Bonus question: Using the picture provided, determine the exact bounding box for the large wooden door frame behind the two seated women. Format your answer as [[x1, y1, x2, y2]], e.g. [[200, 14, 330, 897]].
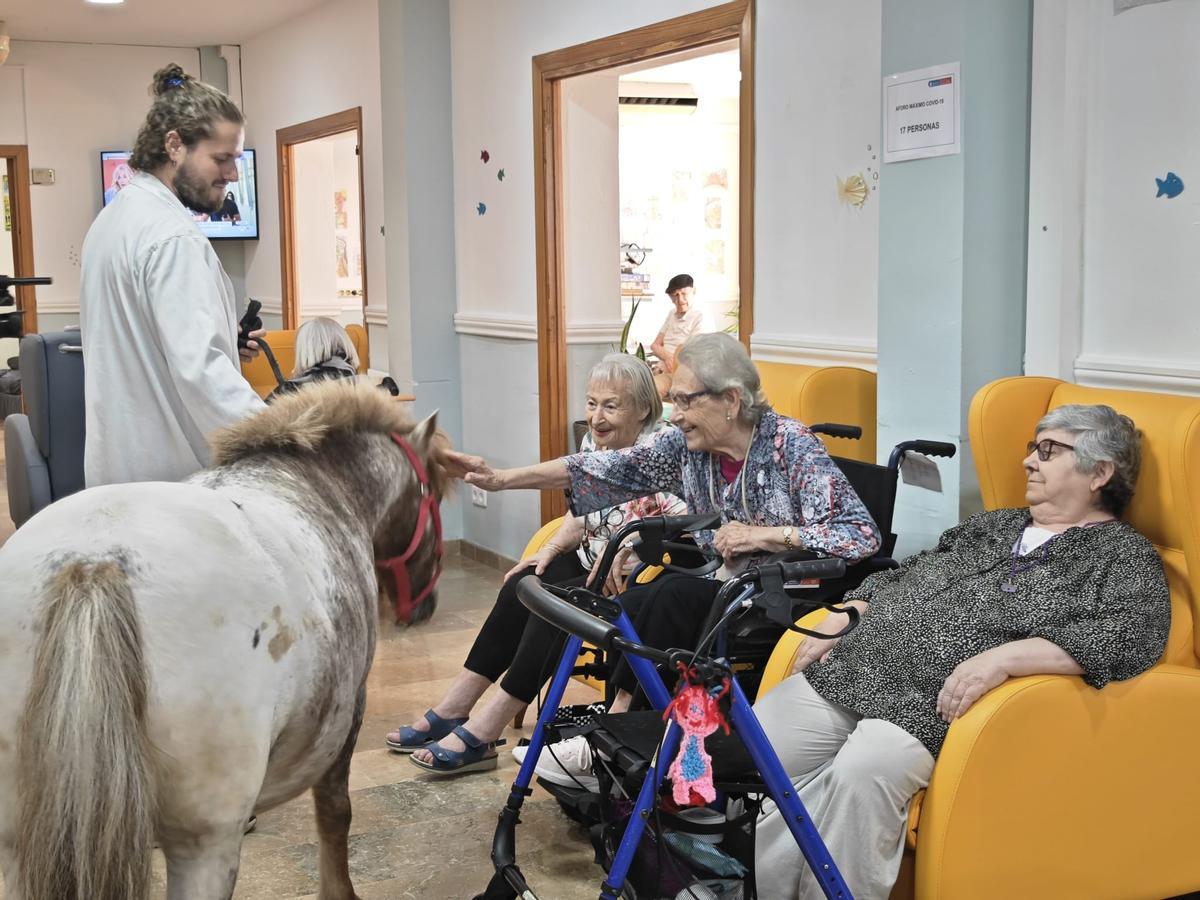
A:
[[533, 0, 755, 522]]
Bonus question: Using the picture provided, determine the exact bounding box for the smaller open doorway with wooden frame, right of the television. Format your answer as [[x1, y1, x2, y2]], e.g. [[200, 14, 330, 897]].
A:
[[276, 108, 367, 345]]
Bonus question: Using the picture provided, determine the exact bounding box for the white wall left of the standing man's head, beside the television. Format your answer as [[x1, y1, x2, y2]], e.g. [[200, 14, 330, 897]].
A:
[[0, 41, 200, 331]]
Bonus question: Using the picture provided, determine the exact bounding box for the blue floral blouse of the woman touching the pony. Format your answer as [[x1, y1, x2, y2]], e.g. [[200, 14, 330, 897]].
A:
[[565, 409, 880, 571]]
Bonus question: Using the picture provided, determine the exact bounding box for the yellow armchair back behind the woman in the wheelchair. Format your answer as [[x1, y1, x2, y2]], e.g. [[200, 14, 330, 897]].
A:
[[755, 362, 877, 462]]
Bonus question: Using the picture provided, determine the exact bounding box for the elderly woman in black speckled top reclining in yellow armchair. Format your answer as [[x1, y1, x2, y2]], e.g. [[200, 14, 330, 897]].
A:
[[755, 406, 1171, 899]]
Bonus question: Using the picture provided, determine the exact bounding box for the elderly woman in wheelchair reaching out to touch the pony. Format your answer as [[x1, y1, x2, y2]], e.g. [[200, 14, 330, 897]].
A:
[[446, 334, 880, 782]]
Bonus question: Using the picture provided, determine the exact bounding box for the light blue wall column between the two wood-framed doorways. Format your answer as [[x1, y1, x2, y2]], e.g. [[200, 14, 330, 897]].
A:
[[379, 0, 466, 540]]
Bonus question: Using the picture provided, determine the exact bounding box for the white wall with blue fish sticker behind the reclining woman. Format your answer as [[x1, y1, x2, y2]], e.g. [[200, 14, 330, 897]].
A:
[[1026, 0, 1200, 394]]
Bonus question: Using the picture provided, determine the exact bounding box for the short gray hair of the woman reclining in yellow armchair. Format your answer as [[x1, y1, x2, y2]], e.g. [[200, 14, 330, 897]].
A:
[[1034, 403, 1141, 516]]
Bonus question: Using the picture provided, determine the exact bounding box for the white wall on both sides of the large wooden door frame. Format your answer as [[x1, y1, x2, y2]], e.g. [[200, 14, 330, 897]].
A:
[[450, 0, 881, 556]]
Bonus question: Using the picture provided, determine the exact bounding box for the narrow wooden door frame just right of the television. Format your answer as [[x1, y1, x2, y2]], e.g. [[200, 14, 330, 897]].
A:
[[275, 107, 367, 331]]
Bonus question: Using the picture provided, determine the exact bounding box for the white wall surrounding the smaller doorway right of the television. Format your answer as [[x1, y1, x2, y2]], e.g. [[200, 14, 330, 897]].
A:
[[241, 0, 396, 376]]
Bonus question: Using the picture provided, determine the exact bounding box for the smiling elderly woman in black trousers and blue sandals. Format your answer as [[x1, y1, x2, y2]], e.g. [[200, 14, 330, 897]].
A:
[[386, 353, 684, 774]]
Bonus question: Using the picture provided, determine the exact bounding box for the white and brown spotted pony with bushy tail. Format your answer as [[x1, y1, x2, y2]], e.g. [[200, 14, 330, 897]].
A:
[[0, 382, 442, 900]]
